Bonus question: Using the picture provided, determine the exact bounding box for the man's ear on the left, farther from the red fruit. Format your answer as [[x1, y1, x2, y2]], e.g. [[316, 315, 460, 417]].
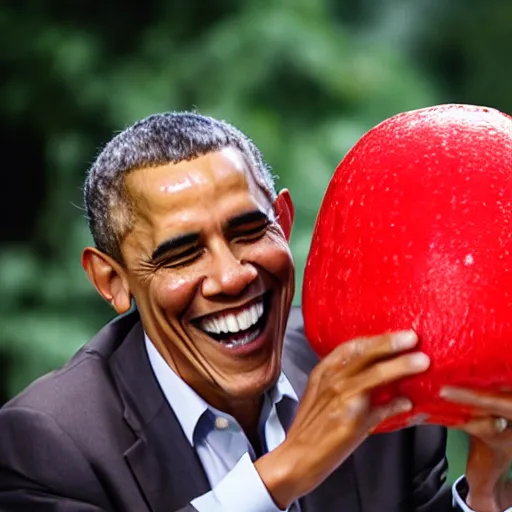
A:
[[82, 247, 131, 315]]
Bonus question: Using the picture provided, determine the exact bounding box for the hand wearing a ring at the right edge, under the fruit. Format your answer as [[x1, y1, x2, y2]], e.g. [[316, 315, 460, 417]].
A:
[[441, 388, 512, 512]]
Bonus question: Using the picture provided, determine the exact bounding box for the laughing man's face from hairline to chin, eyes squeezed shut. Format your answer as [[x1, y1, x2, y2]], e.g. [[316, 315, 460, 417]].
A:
[[121, 148, 294, 405]]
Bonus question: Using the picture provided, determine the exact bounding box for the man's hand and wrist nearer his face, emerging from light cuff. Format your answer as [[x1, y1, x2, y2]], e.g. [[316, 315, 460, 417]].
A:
[[255, 331, 430, 508]]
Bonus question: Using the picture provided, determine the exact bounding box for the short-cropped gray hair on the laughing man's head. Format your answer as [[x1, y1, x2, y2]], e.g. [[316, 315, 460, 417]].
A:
[[84, 112, 276, 263]]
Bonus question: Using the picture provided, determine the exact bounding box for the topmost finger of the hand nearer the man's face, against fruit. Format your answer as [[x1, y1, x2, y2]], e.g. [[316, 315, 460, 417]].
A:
[[324, 331, 418, 373]]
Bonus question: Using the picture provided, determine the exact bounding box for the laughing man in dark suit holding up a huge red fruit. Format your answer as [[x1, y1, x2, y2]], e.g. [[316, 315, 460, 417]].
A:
[[0, 113, 509, 512]]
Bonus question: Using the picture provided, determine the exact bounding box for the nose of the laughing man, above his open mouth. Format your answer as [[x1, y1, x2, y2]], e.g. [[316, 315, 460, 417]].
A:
[[202, 244, 258, 297]]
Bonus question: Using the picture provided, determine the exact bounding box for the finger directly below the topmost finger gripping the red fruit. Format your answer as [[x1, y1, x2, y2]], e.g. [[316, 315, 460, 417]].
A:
[[351, 352, 430, 392]]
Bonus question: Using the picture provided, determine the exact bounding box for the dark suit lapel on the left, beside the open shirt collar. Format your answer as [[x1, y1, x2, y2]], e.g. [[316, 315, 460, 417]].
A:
[[110, 322, 210, 512]]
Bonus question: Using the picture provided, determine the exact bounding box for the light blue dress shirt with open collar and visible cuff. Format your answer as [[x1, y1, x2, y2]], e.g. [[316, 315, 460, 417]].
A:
[[145, 336, 300, 512]]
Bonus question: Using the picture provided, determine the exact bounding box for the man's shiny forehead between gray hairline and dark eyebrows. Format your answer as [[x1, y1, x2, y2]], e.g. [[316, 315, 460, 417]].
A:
[[126, 147, 268, 227]]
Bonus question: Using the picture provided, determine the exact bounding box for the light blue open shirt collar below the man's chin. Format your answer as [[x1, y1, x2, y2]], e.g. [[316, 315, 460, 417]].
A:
[[144, 333, 299, 446]]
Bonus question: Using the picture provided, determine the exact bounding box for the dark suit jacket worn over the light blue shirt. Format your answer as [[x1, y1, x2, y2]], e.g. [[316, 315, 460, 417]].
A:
[[0, 309, 451, 512]]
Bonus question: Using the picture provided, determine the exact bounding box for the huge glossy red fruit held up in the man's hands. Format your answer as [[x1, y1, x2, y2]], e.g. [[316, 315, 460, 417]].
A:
[[303, 105, 512, 432]]
